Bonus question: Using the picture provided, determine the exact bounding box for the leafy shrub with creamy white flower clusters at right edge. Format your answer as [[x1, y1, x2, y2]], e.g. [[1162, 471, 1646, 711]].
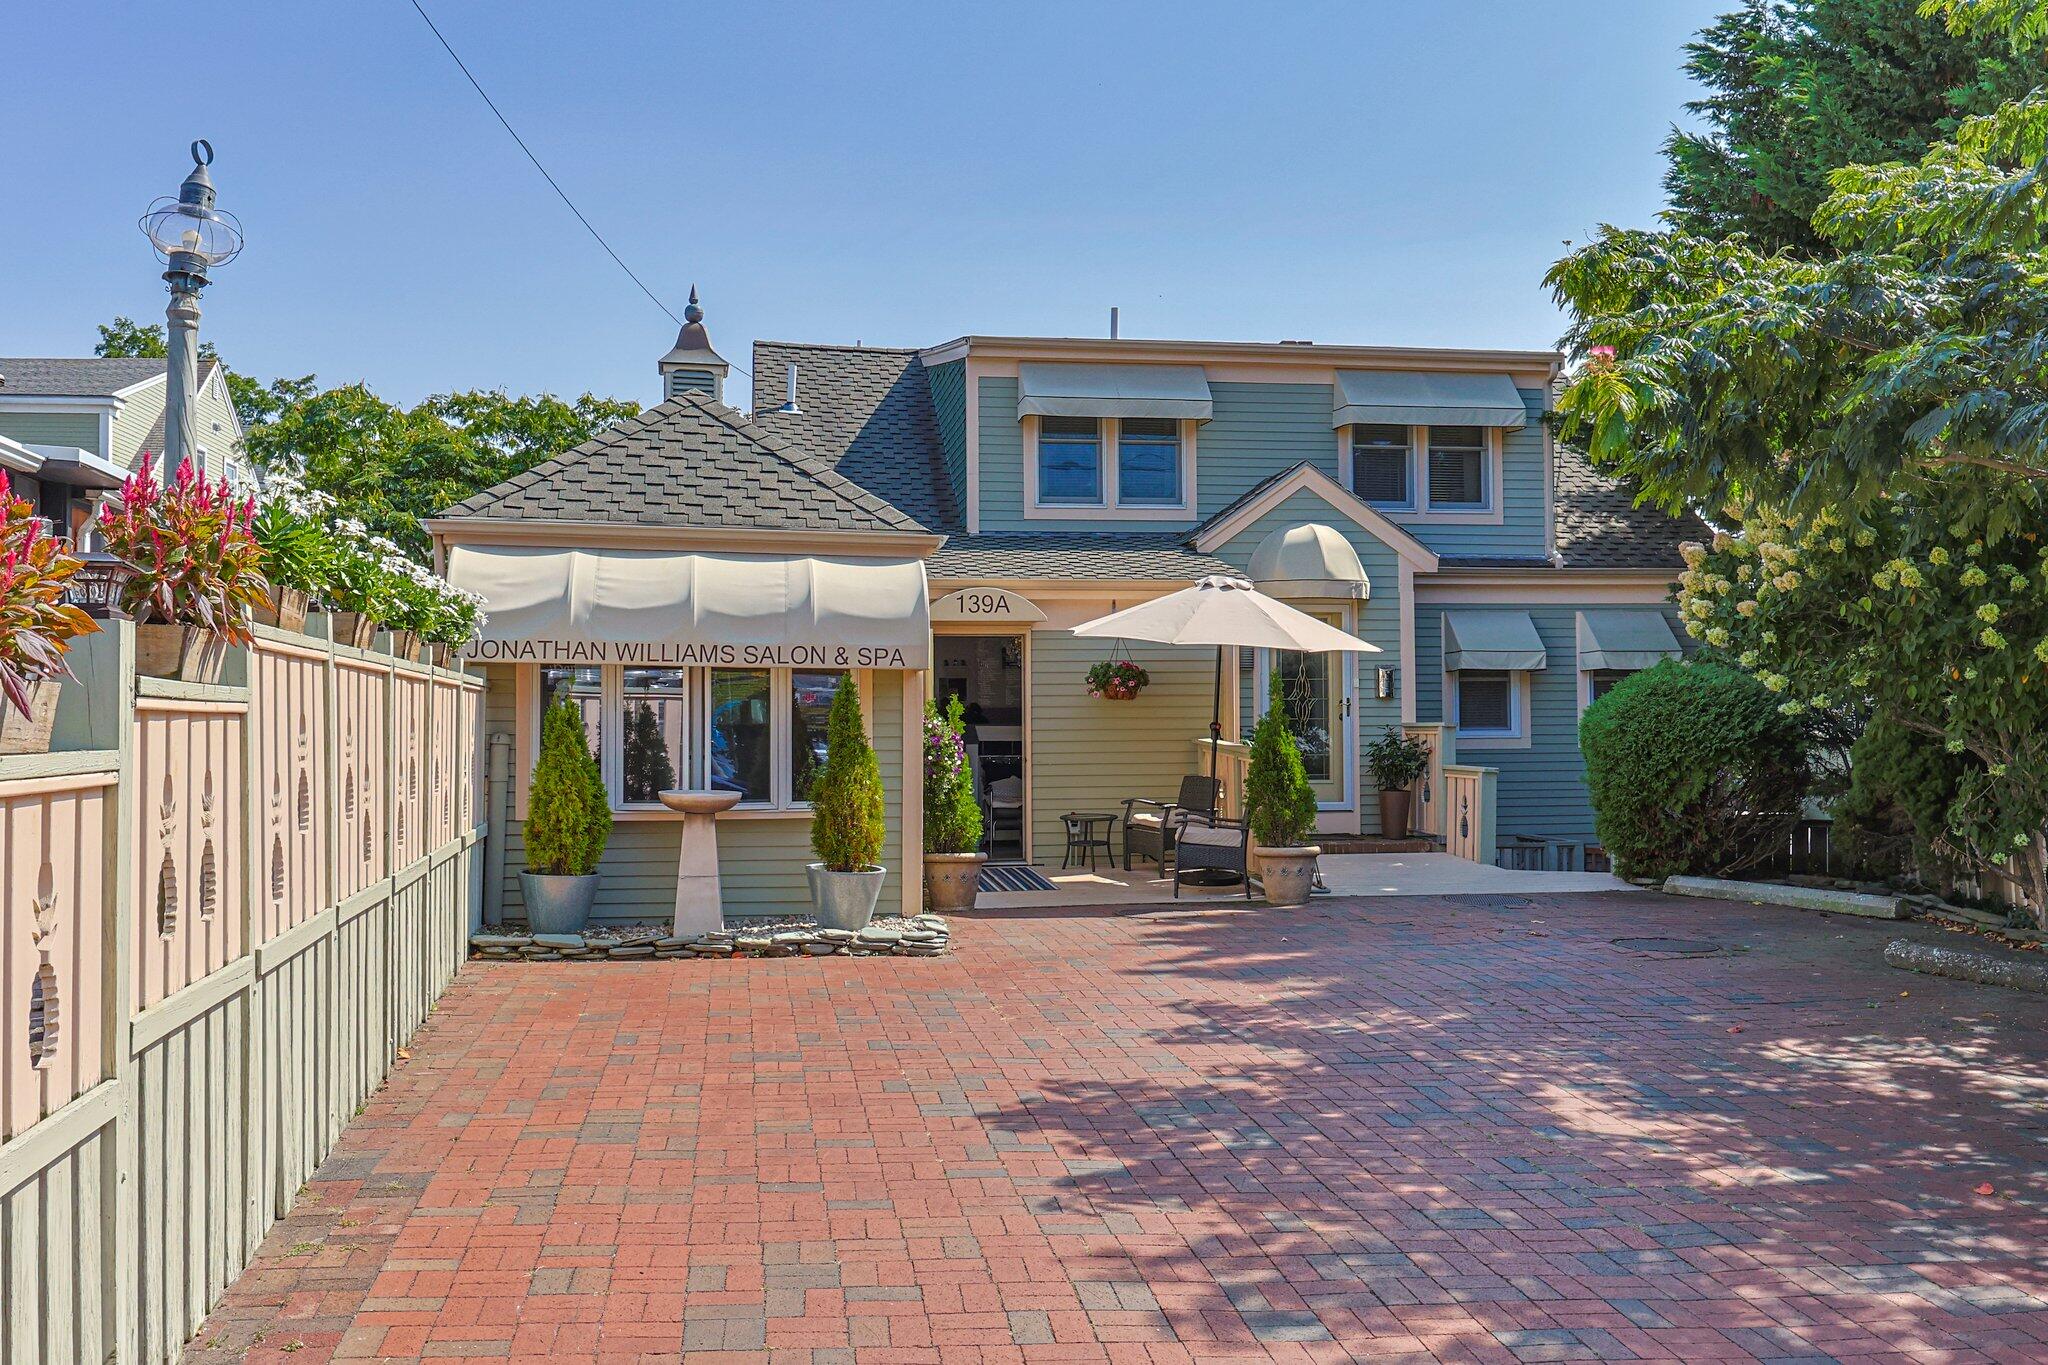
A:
[[1679, 485, 2048, 927]]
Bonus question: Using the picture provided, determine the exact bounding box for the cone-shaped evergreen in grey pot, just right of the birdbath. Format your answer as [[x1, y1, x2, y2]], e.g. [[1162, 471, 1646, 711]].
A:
[[807, 677, 887, 929]]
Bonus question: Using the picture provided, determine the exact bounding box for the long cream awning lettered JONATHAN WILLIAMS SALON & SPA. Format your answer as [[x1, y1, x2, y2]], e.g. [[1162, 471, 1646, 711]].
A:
[[449, 544, 932, 669]]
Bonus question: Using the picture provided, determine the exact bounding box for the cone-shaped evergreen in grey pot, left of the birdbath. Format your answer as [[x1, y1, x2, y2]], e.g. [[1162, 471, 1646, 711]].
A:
[[518, 696, 612, 933]]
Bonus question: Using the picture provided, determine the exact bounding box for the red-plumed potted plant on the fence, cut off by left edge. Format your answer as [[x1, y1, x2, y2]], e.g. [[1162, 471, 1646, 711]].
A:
[[0, 473, 98, 753]]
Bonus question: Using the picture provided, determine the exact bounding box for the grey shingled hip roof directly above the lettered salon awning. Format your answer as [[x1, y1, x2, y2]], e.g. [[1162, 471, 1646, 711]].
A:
[[442, 391, 937, 532]]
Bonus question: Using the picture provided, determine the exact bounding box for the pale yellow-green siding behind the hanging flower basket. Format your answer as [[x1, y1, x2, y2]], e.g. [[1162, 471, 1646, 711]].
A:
[[1030, 626, 1217, 868]]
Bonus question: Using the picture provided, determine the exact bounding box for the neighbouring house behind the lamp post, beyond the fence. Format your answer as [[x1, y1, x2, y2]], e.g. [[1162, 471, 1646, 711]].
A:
[[0, 356, 244, 532]]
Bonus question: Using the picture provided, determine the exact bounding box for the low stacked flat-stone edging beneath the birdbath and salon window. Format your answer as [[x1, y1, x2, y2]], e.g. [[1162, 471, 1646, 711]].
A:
[[469, 915, 952, 962]]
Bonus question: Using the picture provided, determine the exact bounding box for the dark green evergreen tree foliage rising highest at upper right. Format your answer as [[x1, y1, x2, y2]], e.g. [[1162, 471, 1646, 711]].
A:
[[1665, 0, 2038, 254]]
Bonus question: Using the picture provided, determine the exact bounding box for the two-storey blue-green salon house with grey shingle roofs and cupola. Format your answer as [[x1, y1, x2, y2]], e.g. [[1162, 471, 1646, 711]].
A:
[[430, 296, 1706, 915]]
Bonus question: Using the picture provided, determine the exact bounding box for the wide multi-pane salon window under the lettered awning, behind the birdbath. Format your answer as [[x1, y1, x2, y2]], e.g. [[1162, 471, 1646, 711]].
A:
[[528, 665, 848, 810]]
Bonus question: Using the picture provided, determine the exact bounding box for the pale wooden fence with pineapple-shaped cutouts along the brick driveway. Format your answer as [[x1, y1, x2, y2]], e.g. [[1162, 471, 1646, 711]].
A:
[[0, 624, 483, 1365]]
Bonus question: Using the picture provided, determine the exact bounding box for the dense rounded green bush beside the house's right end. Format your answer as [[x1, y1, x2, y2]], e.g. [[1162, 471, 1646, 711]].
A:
[[1579, 659, 1808, 876]]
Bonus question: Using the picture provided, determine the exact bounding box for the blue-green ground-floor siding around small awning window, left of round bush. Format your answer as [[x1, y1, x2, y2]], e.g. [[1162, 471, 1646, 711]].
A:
[[1415, 596, 1690, 839]]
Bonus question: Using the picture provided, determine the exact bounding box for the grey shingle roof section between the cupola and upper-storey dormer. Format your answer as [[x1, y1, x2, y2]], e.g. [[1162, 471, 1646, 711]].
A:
[[754, 342, 958, 532]]
